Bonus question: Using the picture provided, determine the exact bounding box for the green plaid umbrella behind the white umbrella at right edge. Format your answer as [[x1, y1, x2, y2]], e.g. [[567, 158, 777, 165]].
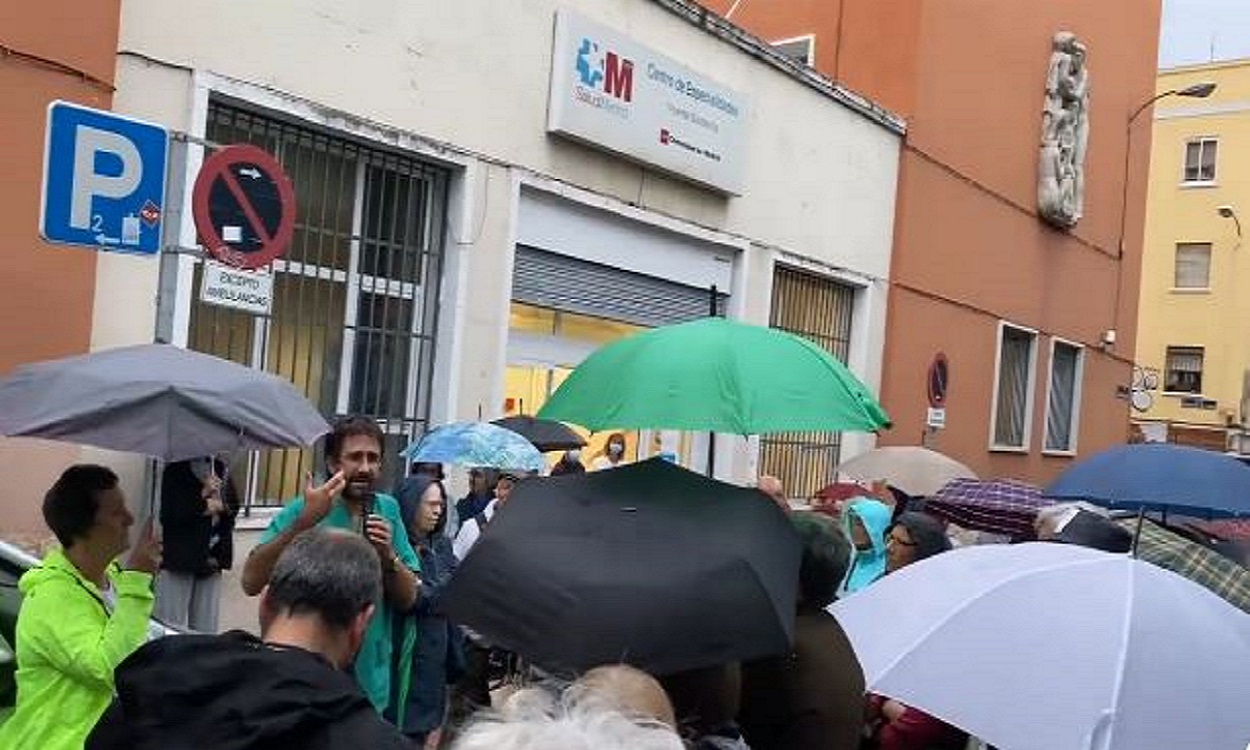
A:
[[1116, 519, 1250, 613]]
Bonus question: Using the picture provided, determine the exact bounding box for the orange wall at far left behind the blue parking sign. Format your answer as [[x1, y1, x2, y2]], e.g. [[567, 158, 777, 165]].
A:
[[0, 0, 120, 533]]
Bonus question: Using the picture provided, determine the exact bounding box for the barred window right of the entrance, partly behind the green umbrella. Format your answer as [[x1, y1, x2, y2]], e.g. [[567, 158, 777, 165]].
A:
[[760, 266, 855, 498]]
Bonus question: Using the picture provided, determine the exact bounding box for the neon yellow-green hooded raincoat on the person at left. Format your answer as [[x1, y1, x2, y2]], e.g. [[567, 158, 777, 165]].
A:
[[0, 550, 153, 750]]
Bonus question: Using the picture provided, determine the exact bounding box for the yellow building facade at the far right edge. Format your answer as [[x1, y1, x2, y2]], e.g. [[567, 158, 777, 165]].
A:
[[1134, 60, 1250, 453]]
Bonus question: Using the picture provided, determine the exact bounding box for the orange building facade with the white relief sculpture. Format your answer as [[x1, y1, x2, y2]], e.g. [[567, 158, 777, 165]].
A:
[[706, 0, 1160, 483]]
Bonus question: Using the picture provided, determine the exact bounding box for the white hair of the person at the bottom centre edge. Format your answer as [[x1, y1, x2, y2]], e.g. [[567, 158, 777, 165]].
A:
[[451, 688, 683, 750]]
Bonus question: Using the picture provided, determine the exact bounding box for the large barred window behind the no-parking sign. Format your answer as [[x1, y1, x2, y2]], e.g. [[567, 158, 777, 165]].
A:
[[189, 101, 448, 505]]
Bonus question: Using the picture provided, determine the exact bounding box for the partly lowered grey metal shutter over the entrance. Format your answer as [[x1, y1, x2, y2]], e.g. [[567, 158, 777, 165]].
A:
[[513, 245, 729, 326]]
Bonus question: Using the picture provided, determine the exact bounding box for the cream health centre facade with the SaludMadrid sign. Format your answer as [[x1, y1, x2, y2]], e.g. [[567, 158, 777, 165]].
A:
[[0, 0, 903, 530]]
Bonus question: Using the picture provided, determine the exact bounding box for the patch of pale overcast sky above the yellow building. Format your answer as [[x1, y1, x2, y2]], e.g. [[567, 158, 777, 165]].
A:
[[1159, 0, 1250, 68]]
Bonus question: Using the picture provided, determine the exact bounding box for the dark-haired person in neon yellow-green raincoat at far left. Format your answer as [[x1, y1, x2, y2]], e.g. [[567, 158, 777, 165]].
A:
[[0, 465, 160, 750]]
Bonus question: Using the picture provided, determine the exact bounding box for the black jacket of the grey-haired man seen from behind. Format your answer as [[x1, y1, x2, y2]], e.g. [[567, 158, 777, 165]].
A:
[[85, 631, 411, 750]]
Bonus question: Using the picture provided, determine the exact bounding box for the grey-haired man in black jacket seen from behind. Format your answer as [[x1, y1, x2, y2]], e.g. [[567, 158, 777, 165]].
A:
[[89, 529, 411, 750]]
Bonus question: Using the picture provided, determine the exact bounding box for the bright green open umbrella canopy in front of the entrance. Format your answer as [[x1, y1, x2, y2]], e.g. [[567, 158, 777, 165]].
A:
[[539, 318, 890, 435]]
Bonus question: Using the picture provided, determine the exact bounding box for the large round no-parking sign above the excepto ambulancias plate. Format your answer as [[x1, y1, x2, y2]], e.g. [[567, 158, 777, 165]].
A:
[[191, 145, 295, 269]]
